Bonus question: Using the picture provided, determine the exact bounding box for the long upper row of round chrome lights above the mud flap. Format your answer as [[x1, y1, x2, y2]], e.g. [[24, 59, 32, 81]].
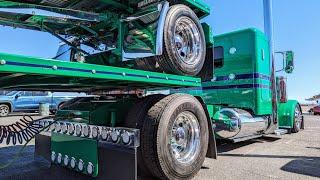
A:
[[39, 120, 139, 147]]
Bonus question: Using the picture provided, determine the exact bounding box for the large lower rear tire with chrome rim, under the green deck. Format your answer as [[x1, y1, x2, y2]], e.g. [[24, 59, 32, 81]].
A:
[[127, 94, 209, 179]]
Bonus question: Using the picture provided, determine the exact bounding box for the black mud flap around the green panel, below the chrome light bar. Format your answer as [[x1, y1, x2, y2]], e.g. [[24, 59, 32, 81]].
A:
[[35, 134, 138, 180]]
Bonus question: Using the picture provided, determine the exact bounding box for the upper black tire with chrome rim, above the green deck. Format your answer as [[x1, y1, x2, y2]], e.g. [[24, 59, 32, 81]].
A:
[[137, 4, 206, 76]]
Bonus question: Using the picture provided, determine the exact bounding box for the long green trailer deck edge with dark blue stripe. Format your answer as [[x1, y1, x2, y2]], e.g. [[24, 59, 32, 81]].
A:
[[0, 53, 201, 92]]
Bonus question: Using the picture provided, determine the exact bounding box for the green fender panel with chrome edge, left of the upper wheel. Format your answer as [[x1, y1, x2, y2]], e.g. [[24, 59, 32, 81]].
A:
[[119, 1, 170, 61]]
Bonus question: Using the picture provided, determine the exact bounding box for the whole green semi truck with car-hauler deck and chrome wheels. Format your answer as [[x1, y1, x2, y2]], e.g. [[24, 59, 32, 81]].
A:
[[0, 0, 303, 179]]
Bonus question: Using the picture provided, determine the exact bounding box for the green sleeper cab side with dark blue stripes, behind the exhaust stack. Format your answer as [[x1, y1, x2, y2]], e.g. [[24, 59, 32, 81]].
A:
[[202, 29, 272, 115]]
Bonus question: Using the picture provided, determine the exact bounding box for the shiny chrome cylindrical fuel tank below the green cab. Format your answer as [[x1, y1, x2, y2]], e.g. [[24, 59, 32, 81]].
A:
[[214, 108, 269, 140]]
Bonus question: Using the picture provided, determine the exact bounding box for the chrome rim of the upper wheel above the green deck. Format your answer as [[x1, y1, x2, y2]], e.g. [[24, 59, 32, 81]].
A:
[[174, 17, 203, 65]]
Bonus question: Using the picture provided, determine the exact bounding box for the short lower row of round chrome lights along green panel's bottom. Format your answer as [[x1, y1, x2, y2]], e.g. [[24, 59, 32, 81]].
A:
[[51, 151, 95, 175]]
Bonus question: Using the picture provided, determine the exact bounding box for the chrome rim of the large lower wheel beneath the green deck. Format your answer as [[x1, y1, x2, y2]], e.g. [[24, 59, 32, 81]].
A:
[[170, 111, 200, 164]]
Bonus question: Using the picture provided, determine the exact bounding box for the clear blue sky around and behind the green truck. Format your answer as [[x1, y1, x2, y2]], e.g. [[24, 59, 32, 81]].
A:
[[0, 0, 320, 101]]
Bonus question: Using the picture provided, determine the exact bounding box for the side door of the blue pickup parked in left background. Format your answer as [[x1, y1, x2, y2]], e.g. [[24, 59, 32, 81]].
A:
[[14, 91, 34, 111]]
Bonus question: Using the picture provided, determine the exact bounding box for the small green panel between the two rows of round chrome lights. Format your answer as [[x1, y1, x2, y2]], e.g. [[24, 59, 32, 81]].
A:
[[51, 132, 99, 177]]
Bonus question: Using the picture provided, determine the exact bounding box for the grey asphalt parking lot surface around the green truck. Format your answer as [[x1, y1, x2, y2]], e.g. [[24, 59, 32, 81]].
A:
[[0, 115, 320, 180]]
